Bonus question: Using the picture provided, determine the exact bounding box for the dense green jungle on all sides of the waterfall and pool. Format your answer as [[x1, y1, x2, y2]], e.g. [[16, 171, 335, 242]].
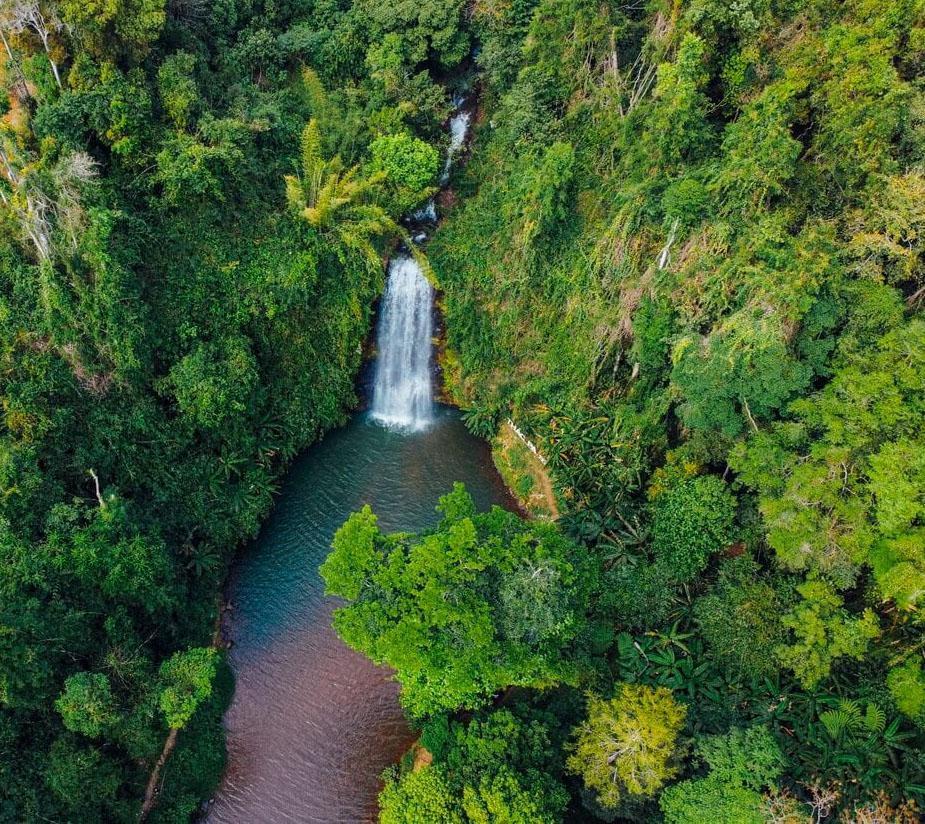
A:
[[0, 0, 925, 824]]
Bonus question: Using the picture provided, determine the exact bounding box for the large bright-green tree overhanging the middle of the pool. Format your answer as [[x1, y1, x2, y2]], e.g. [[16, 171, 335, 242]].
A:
[[321, 484, 584, 717]]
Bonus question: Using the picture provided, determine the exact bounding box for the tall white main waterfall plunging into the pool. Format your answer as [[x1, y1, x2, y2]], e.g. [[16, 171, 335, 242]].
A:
[[372, 254, 433, 431]]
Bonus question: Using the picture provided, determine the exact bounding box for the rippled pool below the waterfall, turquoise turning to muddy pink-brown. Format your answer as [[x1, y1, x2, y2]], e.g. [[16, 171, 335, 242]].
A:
[[208, 407, 511, 824]]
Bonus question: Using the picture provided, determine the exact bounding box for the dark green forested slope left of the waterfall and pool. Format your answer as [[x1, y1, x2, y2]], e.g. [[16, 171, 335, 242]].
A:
[[0, 0, 458, 822]]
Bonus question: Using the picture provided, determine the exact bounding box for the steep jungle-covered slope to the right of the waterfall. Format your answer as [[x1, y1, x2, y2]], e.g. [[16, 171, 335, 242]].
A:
[[430, 0, 925, 821]]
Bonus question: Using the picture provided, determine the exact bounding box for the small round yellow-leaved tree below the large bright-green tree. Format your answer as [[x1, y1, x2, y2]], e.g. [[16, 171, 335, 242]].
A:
[[567, 684, 687, 807]]
